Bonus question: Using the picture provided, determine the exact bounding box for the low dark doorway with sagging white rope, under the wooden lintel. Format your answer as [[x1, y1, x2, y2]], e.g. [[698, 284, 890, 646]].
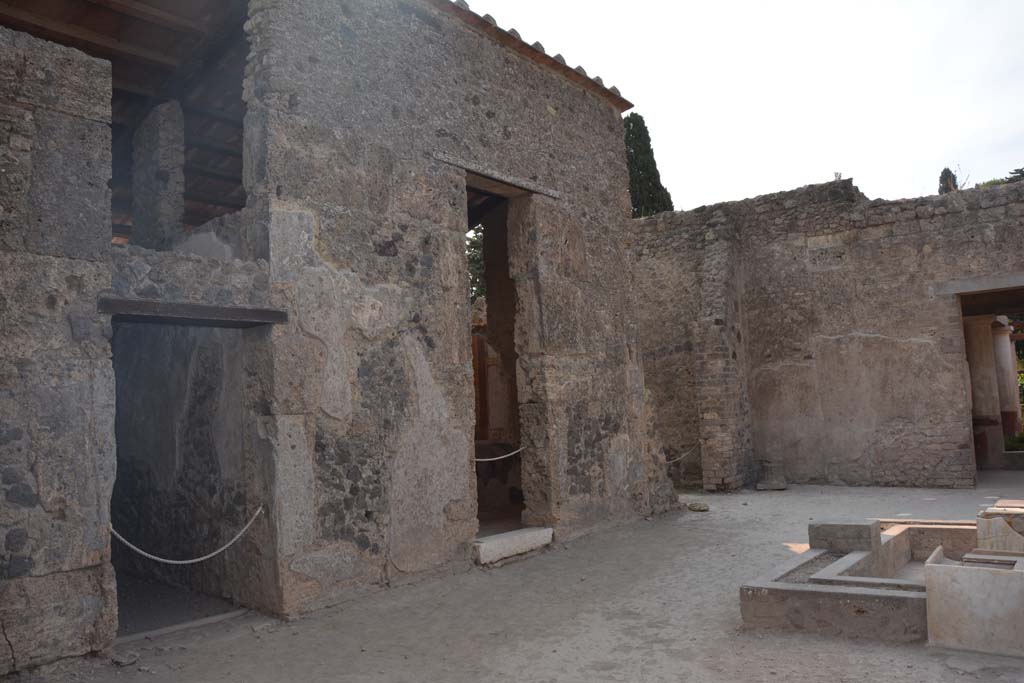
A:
[[111, 321, 255, 637]]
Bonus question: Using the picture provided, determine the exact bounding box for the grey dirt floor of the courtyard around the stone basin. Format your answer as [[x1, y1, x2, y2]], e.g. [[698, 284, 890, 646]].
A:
[[19, 472, 1024, 683]]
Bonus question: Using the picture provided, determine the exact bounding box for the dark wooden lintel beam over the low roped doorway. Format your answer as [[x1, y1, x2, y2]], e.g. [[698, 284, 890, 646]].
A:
[[96, 297, 288, 328]]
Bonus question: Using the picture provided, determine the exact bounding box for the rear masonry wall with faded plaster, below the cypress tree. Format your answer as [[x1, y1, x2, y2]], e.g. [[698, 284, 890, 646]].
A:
[[631, 180, 1024, 487]]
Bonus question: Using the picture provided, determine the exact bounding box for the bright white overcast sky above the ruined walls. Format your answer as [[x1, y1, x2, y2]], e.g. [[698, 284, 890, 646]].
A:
[[469, 0, 1024, 209]]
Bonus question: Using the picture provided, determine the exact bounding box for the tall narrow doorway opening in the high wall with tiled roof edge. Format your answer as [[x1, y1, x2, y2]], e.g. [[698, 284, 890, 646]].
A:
[[467, 183, 525, 537]]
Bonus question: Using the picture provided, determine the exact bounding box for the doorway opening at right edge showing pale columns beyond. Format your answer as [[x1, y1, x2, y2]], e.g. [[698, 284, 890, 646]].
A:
[[961, 288, 1024, 470]]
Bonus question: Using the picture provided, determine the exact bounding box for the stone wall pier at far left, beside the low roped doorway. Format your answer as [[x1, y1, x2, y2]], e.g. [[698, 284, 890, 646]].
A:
[[0, 29, 116, 675]]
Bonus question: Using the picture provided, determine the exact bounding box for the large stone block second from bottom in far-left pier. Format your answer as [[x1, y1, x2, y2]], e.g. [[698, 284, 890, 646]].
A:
[[0, 359, 115, 578]]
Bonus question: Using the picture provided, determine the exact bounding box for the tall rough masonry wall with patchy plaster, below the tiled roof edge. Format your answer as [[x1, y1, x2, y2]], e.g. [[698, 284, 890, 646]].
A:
[[246, 0, 669, 612]]
